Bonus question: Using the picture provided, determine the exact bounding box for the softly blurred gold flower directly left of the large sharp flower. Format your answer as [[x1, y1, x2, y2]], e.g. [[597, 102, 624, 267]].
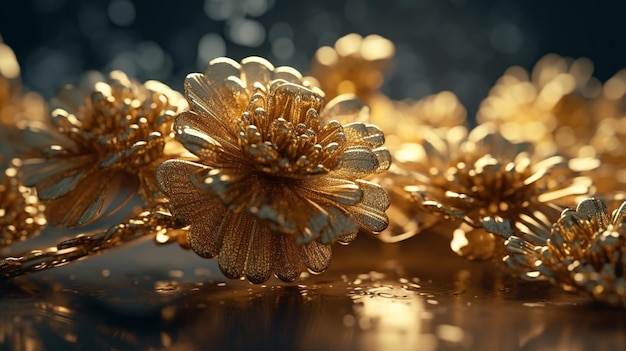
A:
[[22, 71, 186, 227]]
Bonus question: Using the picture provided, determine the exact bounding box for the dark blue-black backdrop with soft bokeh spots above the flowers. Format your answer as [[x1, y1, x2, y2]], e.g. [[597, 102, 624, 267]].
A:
[[0, 0, 626, 117]]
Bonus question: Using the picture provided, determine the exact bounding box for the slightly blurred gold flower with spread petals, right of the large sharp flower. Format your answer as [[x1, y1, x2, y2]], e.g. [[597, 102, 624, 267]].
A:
[[376, 124, 597, 259]]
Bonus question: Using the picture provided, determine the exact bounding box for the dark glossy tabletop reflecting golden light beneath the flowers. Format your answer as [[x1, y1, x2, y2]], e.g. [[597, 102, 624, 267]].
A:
[[0, 233, 626, 350]]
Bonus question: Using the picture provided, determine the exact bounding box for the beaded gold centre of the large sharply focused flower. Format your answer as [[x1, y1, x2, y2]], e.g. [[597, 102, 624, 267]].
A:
[[237, 80, 346, 178]]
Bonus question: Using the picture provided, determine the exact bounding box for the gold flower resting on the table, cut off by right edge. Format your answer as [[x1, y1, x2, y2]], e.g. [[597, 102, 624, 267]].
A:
[[506, 199, 626, 306]]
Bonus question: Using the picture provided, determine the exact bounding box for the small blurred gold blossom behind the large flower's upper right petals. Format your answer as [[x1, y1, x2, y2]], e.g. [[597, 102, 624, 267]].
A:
[[309, 33, 395, 103]]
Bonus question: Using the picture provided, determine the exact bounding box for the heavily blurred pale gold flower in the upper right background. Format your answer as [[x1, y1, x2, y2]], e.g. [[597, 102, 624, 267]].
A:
[[476, 54, 595, 152]]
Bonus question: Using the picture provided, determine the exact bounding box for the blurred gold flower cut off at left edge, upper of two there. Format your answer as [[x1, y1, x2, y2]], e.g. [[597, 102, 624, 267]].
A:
[[0, 38, 47, 163]]
